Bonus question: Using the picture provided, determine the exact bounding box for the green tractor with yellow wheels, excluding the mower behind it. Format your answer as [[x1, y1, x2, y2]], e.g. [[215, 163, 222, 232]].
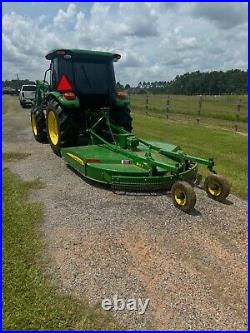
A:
[[31, 50, 132, 155]]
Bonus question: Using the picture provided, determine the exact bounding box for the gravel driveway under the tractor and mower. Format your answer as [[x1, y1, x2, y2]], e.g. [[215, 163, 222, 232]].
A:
[[3, 97, 247, 330]]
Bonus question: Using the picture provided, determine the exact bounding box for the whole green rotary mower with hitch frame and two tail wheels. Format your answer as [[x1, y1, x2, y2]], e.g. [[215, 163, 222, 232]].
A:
[[58, 110, 230, 212]]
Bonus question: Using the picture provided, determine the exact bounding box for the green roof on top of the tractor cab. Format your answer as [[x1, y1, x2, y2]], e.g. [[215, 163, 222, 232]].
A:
[[45, 49, 121, 61]]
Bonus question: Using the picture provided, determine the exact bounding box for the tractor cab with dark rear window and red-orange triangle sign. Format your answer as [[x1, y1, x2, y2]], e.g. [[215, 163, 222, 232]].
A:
[[46, 49, 121, 108]]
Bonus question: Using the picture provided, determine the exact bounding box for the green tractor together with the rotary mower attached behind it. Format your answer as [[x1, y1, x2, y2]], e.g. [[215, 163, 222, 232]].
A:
[[31, 49, 230, 212]]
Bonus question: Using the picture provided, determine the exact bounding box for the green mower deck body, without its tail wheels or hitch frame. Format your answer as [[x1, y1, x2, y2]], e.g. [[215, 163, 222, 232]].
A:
[[61, 141, 198, 191]]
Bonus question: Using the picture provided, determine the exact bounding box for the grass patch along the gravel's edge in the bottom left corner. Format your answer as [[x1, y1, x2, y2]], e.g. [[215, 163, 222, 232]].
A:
[[2, 153, 116, 330]]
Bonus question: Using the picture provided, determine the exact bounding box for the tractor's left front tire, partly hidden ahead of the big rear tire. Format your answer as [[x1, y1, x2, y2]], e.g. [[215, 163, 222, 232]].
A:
[[30, 108, 47, 143]]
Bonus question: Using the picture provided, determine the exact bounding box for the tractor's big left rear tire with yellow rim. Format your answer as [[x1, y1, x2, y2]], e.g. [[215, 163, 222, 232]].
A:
[[46, 100, 79, 156]]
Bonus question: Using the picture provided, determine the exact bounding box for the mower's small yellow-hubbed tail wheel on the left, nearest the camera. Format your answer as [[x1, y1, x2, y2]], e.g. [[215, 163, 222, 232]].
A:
[[171, 181, 196, 212]]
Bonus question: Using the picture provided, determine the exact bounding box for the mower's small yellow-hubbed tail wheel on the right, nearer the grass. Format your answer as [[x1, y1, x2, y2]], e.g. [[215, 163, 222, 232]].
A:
[[204, 175, 231, 201]]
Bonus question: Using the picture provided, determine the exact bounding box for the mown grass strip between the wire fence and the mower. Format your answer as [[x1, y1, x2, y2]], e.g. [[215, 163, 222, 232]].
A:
[[133, 113, 248, 199]]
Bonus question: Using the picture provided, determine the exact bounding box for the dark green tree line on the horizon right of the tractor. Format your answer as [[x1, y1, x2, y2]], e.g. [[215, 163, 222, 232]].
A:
[[117, 69, 248, 95]]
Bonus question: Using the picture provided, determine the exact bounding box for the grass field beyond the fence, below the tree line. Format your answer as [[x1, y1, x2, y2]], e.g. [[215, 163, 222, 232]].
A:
[[130, 95, 248, 131]]
